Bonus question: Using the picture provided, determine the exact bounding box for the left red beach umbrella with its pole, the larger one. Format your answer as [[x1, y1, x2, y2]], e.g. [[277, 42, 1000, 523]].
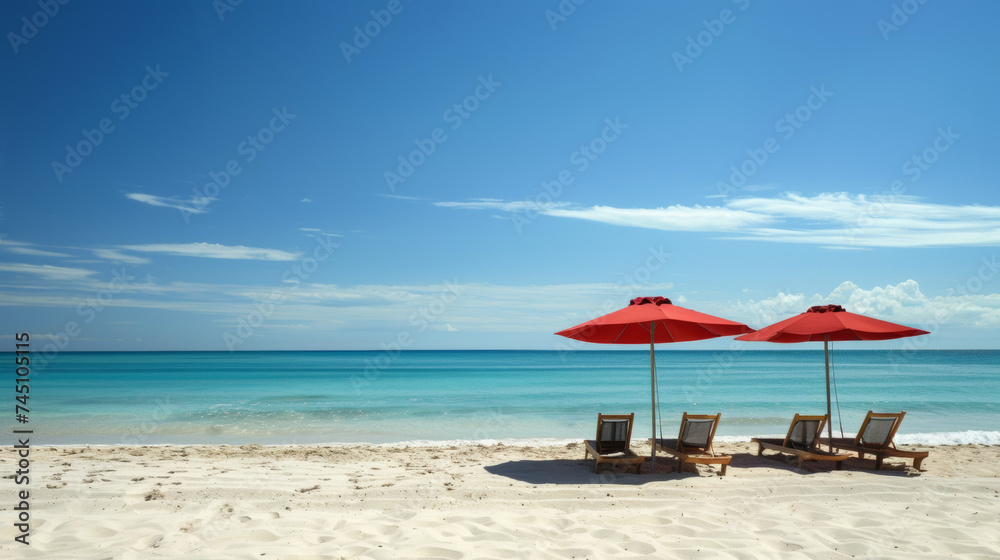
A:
[[556, 297, 753, 465]]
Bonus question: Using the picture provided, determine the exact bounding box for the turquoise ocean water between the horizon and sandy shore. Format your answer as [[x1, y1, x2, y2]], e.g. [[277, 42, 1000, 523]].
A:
[[13, 348, 1000, 445]]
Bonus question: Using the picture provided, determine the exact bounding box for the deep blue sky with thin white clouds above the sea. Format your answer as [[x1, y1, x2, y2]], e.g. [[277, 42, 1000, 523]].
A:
[[0, 0, 1000, 350]]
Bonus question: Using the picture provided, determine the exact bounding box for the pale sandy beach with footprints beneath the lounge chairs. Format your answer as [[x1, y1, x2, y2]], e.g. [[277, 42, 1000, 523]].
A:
[[0, 443, 1000, 559]]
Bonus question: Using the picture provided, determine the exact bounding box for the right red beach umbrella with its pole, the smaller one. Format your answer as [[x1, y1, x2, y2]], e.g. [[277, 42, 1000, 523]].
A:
[[736, 305, 930, 439]]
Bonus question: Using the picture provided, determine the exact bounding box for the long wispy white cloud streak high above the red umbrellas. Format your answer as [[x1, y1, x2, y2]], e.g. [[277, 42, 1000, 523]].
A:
[[434, 193, 1000, 249]]
